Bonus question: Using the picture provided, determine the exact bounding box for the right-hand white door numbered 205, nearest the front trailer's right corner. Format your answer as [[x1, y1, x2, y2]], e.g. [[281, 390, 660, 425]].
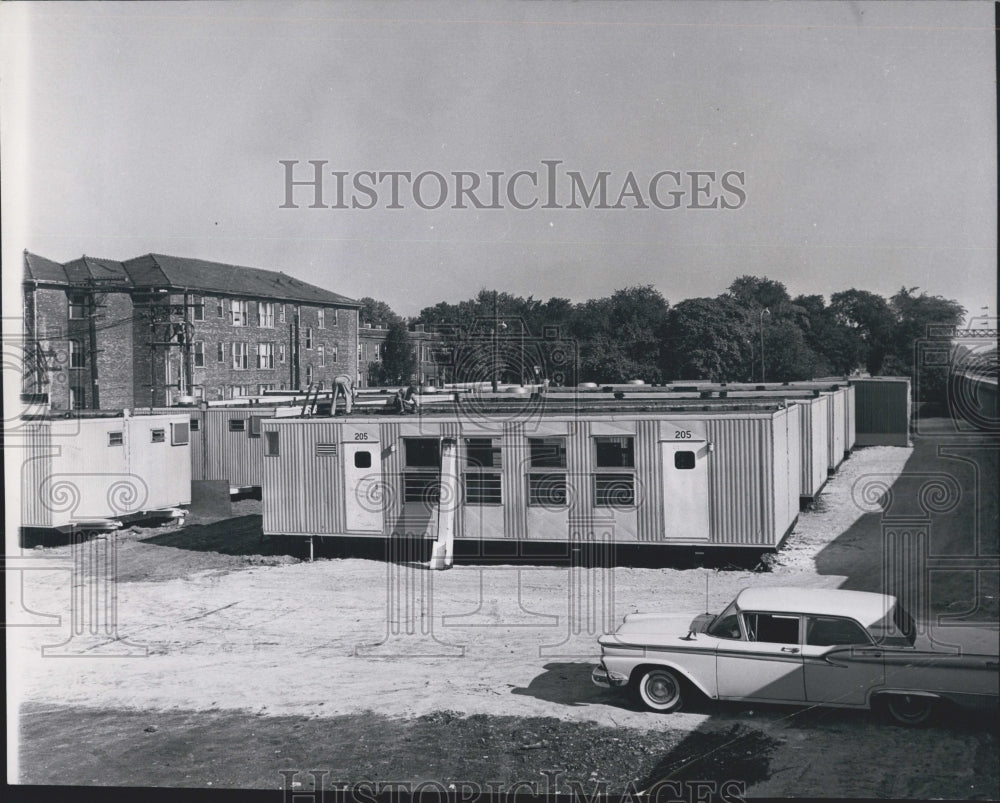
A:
[[660, 422, 711, 543]]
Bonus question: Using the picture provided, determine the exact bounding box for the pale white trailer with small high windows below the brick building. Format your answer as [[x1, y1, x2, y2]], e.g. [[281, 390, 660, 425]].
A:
[[21, 414, 191, 529]]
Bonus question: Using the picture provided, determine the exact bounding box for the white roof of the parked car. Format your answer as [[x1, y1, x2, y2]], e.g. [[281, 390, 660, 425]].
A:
[[736, 586, 896, 626]]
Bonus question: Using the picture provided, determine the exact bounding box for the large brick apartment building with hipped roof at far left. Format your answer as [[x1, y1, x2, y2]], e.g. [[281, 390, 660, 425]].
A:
[[23, 251, 360, 410]]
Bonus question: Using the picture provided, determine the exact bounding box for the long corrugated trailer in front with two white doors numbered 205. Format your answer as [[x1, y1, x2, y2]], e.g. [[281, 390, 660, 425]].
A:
[[261, 403, 800, 551]]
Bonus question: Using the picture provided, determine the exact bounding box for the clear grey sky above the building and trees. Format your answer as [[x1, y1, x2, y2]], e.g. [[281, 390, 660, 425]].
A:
[[0, 1, 997, 326]]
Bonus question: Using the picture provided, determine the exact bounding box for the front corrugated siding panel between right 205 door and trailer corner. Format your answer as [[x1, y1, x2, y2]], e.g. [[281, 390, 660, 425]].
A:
[[705, 418, 775, 546]]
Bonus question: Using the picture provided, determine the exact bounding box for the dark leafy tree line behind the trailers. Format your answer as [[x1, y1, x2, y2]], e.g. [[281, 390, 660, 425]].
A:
[[360, 276, 965, 406]]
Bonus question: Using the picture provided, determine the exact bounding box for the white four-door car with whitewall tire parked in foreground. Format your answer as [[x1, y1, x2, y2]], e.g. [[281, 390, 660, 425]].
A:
[[592, 587, 1000, 725]]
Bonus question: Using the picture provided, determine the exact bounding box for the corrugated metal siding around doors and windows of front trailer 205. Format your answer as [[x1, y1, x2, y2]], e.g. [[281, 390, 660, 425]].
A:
[[262, 411, 799, 546]]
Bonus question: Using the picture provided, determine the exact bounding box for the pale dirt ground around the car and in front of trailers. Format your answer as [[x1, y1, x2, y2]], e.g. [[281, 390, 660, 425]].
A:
[[8, 424, 1000, 800]]
